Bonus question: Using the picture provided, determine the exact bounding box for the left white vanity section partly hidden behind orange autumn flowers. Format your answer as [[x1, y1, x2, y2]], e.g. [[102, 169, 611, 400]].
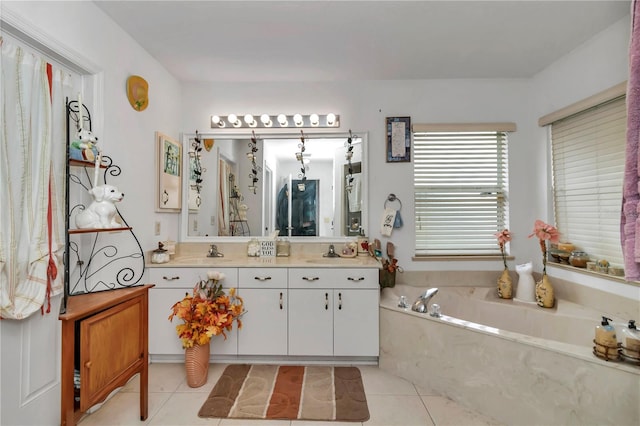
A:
[[148, 267, 238, 360]]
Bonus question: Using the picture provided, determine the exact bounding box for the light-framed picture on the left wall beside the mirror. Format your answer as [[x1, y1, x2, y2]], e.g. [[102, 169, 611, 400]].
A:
[[156, 132, 182, 213]]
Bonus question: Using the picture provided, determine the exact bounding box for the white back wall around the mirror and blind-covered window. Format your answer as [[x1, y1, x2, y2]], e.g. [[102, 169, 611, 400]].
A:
[[183, 80, 545, 270]]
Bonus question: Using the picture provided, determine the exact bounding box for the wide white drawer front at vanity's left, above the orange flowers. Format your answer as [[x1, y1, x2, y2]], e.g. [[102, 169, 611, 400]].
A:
[[148, 268, 238, 288]]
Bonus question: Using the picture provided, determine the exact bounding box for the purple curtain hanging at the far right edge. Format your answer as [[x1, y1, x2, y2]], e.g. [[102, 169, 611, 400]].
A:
[[620, 0, 640, 281]]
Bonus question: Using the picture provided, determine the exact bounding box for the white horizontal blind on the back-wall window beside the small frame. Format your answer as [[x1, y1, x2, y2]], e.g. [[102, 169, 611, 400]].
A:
[[413, 131, 508, 255]]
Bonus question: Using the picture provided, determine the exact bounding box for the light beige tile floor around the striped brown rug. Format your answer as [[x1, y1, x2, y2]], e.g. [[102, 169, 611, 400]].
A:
[[79, 363, 499, 426]]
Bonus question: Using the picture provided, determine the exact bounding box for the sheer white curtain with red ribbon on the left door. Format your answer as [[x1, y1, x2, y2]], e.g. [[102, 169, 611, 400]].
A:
[[0, 37, 71, 319]]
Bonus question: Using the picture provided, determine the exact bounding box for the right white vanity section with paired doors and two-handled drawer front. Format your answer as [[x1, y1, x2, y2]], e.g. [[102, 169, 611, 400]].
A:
[[289, 268, 380, 357]]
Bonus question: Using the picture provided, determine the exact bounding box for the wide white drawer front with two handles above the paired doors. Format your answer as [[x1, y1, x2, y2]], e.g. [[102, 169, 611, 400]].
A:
[[289, 268, 378, 289]]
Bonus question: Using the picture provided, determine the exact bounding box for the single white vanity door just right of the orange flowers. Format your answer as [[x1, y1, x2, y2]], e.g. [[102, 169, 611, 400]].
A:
[[238, 288, 287, 355]]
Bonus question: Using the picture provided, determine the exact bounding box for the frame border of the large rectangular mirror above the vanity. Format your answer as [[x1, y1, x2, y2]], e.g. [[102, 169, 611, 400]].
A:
[[178, 128, 371, 243]]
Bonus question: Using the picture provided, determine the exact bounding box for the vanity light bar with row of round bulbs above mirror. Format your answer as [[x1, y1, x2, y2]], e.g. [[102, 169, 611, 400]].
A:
[[211, 113, 340, 129]]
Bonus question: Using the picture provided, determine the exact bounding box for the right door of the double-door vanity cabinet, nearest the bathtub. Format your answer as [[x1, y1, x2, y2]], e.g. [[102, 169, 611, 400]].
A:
[[333, 289, 380, 356]]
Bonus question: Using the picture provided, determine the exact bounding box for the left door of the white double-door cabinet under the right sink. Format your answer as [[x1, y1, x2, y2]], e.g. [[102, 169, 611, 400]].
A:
[[289, 289, 333, 356]]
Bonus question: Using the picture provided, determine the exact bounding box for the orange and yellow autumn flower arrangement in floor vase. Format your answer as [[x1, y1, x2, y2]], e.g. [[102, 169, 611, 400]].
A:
[[169, 271, 244, 348]]
